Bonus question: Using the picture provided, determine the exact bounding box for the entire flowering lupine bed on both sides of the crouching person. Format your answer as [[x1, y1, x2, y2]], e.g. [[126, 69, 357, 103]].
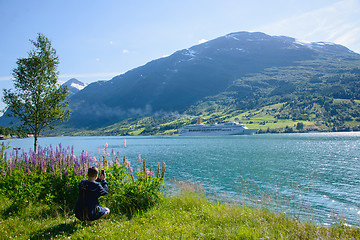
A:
[[0, 142, 165, 217]]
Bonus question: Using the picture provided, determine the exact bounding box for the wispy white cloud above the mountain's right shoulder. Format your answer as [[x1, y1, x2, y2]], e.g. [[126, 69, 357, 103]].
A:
[[256, 0, 360, 53]]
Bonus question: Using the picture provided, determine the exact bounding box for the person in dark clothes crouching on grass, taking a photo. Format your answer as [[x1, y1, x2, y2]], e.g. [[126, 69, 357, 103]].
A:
[[75, 167, 110, 221]]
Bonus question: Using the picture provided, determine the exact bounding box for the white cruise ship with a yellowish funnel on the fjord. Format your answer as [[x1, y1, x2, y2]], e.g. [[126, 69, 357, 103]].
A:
[[179, 120, 259, 136]]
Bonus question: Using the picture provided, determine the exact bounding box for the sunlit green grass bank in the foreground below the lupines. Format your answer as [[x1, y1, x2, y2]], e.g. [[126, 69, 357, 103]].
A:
[[0, 185, 360, 239]]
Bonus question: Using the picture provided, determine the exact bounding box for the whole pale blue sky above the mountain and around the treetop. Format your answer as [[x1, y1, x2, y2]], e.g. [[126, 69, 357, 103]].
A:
[[0, 0, 360, 88]]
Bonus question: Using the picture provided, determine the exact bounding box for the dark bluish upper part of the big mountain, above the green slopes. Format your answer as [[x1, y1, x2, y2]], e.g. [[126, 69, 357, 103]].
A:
[[64, 32, 360, 129]]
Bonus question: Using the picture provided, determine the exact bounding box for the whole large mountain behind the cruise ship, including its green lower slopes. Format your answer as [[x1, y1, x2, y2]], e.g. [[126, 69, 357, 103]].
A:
[[0, 32, 360, 135]]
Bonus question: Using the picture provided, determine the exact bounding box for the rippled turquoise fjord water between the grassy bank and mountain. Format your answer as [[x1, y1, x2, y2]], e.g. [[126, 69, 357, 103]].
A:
[[4, 132, 360, 226]]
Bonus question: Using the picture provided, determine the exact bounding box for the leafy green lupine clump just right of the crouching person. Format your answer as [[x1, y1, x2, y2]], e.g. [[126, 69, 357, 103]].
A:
[[98, 143, 165, 218]]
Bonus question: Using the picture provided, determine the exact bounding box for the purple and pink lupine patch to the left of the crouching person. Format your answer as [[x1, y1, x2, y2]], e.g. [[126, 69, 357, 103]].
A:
[[0, 144, 85, 210]]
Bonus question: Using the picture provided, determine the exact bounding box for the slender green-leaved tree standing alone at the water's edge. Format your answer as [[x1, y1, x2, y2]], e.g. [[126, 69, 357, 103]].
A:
[[3, 33, 70, 151]]
